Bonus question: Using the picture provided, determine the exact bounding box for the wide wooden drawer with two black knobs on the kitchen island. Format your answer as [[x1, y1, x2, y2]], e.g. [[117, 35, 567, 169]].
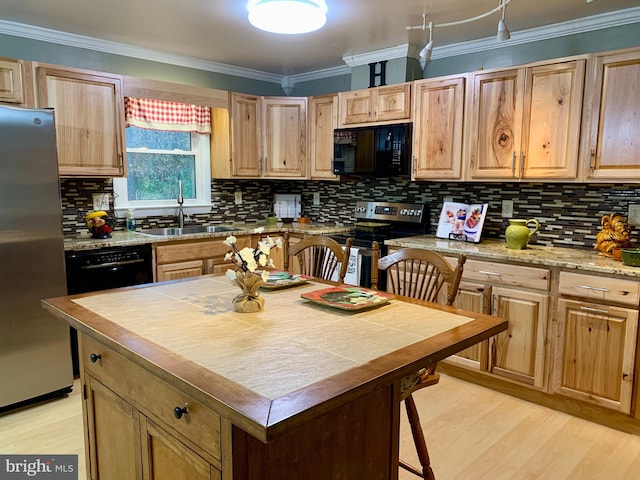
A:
[[80, 335, 221, 460]]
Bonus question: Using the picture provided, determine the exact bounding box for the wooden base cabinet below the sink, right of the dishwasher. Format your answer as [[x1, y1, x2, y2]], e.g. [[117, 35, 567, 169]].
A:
[[155, 235, 252, 282]]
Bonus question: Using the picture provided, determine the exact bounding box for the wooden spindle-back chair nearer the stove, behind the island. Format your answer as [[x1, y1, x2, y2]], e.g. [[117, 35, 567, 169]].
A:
[[284, 232, 353, 283]]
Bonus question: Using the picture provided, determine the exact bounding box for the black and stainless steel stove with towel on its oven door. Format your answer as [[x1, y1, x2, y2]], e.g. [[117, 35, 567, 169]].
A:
[[331, 202, 429, 289]]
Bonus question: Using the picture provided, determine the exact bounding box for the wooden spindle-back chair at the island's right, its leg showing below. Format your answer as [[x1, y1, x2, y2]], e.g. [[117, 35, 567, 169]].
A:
[[371, 242, 467, 480]]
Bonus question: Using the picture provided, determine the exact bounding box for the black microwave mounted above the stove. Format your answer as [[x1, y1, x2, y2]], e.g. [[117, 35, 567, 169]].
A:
[[333, 123, 413, 177]]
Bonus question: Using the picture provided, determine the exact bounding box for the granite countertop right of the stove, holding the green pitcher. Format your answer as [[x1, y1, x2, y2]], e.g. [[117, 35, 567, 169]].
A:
[[385, 235, 640, 277]]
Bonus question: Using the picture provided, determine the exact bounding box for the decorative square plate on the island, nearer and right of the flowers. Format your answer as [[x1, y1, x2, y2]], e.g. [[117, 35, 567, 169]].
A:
[[300, 285, 395, 312]]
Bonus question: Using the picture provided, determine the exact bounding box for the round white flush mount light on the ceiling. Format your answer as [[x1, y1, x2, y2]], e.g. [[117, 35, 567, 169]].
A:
[[247, 0, 327, 34]]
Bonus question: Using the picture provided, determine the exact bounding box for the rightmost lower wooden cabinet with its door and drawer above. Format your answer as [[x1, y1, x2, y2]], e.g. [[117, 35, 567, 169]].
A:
[[552, 272, 640, 414]]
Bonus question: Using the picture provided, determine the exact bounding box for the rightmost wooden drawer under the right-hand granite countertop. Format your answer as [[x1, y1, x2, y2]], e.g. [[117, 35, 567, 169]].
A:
[[559, 272, 640, 307]]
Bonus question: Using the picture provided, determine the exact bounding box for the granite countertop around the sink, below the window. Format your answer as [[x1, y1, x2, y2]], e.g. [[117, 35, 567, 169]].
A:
[[64, 222, 351, 250]]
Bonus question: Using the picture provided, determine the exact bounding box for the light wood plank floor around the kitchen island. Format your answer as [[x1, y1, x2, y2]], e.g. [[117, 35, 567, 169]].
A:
[[0, 375, 640, 480]]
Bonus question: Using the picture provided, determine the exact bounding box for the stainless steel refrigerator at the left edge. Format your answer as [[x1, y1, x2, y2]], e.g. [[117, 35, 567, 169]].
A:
[[0, 106, 73, 410]]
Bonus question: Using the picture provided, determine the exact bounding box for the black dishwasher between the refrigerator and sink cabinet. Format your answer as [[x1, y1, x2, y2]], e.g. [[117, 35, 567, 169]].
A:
[[65, 244, 153, 375]]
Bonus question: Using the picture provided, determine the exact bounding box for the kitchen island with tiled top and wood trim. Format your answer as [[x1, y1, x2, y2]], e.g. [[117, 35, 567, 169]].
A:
[[43, 276, 507, 480]]
